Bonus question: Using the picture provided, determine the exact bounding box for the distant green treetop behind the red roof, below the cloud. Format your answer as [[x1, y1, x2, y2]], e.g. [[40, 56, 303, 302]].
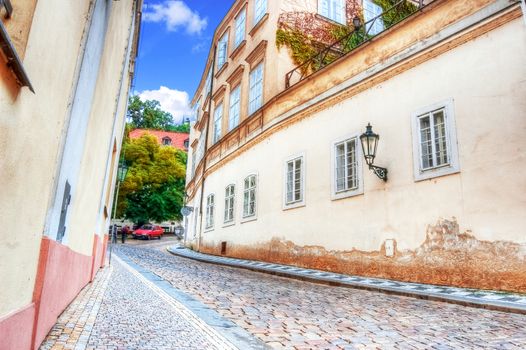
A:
[[127, 95, 174, 130]]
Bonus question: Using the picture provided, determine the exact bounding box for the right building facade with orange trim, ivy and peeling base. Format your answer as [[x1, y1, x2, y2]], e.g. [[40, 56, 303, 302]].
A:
[[187, 0, 526, 292]]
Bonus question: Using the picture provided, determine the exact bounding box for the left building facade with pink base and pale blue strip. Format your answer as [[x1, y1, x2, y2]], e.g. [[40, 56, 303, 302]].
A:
[[0, 0, 142, 349]]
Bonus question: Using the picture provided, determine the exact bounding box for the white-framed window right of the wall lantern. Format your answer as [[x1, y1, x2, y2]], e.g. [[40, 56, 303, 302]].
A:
[[413, 101, 460, 181]]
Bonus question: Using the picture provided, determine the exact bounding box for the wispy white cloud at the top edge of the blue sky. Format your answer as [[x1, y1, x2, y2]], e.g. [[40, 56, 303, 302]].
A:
[[146, 0, 208, 34]]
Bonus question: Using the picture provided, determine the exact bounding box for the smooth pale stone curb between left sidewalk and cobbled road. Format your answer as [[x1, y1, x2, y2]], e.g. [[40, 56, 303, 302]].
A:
[[116, 250, 269, 350]]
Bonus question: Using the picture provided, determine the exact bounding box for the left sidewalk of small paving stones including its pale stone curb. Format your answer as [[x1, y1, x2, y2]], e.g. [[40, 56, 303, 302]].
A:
[[40, 254, 266, 350]]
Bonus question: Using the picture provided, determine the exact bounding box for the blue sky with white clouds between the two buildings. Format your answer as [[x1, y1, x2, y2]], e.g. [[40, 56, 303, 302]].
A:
[[132, 0, 234, 123]]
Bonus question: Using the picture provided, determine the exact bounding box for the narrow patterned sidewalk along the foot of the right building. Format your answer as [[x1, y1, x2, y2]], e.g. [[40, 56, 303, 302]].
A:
[[167, 245, 526, 314]]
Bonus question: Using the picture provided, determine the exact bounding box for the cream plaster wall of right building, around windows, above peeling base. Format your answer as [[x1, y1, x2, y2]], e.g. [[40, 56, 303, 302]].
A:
[[190, 18, 526, 288]]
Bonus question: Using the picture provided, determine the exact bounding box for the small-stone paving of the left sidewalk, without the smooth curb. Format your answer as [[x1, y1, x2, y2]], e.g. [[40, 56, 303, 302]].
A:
[[41, 245, 237, 350]]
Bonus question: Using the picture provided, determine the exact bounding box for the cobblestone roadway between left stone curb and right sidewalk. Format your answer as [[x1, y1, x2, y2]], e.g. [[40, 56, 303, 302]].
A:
[[115, 243, 526, 349]]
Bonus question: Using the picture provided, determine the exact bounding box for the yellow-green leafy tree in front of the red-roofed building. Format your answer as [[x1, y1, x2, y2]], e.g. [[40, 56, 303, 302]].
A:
[[117, 134, 186, 224]]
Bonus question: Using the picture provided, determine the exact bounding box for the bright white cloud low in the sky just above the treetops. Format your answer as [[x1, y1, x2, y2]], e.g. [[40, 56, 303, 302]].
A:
[[138, 86, 192, 124]]
